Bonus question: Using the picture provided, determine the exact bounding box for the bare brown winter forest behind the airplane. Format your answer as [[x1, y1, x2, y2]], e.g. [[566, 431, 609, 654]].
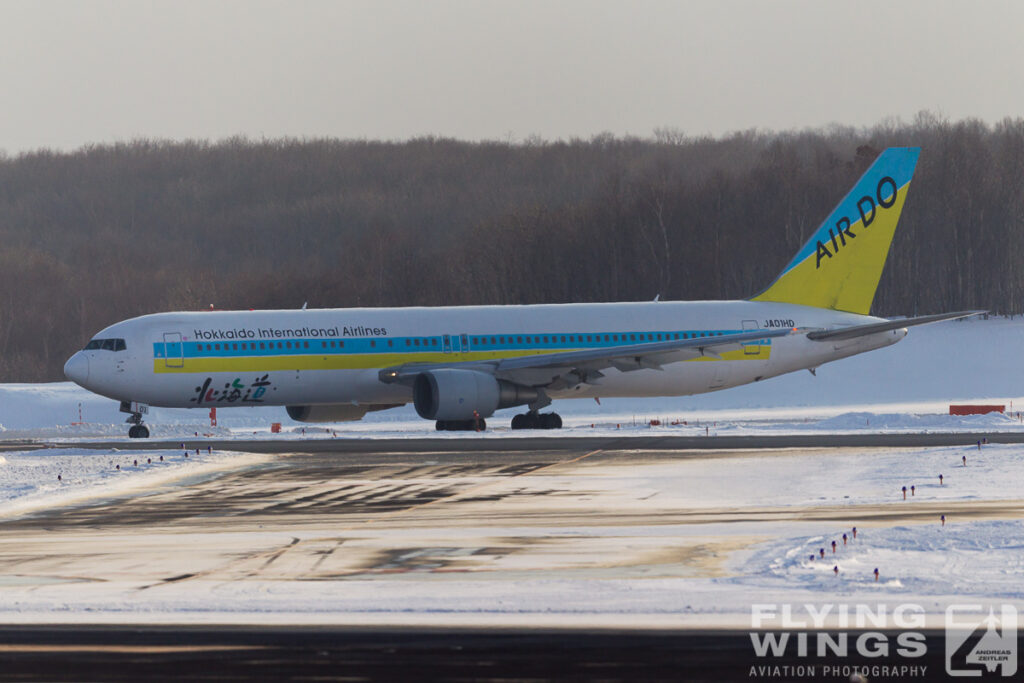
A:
[[0, 113, 1024, 382]]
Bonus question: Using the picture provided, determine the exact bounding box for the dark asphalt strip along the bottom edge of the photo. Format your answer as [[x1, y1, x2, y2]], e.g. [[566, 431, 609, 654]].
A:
[[0, 626, 999, 683]]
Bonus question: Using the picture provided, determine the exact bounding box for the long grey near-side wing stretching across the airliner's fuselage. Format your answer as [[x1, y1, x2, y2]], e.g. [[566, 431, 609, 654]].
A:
[[379, 329, 796, 389]]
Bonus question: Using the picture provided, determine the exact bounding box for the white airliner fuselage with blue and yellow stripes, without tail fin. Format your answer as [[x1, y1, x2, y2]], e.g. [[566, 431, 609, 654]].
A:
[[66, 301, 906, 408]]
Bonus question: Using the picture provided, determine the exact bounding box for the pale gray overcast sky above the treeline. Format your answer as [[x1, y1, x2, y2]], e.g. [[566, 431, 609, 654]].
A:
[[0, 0, 1024, 154]]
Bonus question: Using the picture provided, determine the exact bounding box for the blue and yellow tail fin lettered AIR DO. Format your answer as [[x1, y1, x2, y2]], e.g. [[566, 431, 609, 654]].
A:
[[752, 147, 921, 315]]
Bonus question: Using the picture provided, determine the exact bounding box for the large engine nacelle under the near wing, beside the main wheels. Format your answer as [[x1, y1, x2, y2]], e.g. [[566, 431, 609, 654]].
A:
[[413, 369, 538, 420]]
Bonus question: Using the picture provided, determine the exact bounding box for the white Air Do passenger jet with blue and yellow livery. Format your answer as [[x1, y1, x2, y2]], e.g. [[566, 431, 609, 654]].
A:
[[63, 147, 982, 437]]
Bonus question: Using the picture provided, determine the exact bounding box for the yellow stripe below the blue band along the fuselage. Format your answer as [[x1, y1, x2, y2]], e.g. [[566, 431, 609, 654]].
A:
[[153, 345, 771, 374]]
